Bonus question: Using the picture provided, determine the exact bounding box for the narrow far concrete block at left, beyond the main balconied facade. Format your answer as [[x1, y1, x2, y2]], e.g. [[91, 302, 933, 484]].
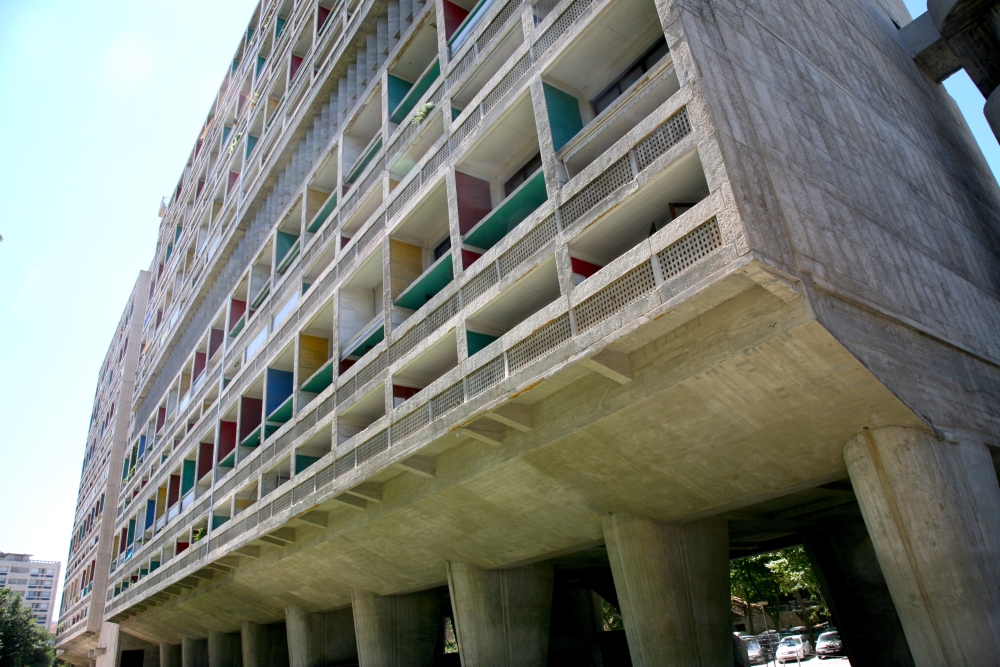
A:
[[53, 271, 150, 665]]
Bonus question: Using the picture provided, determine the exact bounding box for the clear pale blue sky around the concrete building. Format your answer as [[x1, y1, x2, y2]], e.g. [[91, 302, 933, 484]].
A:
[[0, 0, 1000, 612]]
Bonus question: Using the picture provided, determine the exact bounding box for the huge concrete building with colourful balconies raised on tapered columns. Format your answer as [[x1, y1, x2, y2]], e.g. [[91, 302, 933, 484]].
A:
[[74, 0, 1000, 667]]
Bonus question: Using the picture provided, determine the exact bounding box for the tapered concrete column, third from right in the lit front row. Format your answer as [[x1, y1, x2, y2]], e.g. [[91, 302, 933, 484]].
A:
[[448, 563, 553, 667]]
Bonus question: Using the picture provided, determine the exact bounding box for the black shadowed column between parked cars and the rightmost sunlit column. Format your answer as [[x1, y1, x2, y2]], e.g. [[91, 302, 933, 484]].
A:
[[802, 516, 913, 667]]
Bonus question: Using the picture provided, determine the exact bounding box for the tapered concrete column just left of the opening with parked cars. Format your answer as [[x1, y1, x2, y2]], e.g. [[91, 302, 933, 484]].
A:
[[604, 514, 733, 667]]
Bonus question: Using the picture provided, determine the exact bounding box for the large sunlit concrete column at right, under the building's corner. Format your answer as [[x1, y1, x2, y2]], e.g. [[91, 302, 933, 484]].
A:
[[844, 427, 1000, 667]]
